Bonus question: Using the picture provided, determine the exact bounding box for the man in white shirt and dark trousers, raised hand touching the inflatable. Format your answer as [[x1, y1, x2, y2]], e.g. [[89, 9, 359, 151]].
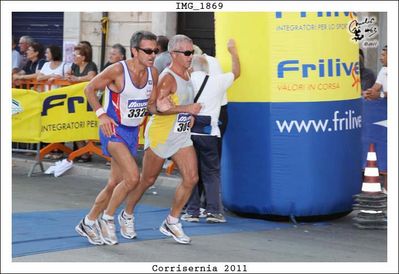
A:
[[181, 39, 240, 223]]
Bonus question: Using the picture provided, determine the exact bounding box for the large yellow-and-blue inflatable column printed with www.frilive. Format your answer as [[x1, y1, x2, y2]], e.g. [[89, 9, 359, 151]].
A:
[[215, 12, 362, 217]]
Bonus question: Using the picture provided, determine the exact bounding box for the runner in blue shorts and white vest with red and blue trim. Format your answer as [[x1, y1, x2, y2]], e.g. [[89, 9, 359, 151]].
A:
[[75, 31, 171, 245]]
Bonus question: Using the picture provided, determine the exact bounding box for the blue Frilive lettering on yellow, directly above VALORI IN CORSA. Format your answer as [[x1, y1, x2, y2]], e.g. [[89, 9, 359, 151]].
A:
[[277, 58, 359, 78]]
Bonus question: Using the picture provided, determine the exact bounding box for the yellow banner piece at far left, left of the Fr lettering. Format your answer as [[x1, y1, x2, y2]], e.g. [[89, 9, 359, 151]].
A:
[[12, 88, 41, 143]]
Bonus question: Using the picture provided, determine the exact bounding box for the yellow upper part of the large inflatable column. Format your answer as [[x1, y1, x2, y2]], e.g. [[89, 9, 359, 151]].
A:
[[215, 12, 360, 102]]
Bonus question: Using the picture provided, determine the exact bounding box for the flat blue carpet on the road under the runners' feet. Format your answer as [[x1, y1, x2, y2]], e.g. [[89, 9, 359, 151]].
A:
[[12, 205, 292, 257]]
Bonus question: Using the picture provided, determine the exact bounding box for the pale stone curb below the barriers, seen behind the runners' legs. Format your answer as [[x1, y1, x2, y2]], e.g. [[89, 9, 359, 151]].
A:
[[12, 157, 181, 188]]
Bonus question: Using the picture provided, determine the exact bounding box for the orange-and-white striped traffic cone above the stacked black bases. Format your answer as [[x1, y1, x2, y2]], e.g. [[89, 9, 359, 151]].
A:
[[362, 144, 382, 194]]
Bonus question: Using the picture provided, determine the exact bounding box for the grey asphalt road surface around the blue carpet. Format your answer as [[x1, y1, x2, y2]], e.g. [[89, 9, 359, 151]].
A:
[[4, 157, 396, 272]]
